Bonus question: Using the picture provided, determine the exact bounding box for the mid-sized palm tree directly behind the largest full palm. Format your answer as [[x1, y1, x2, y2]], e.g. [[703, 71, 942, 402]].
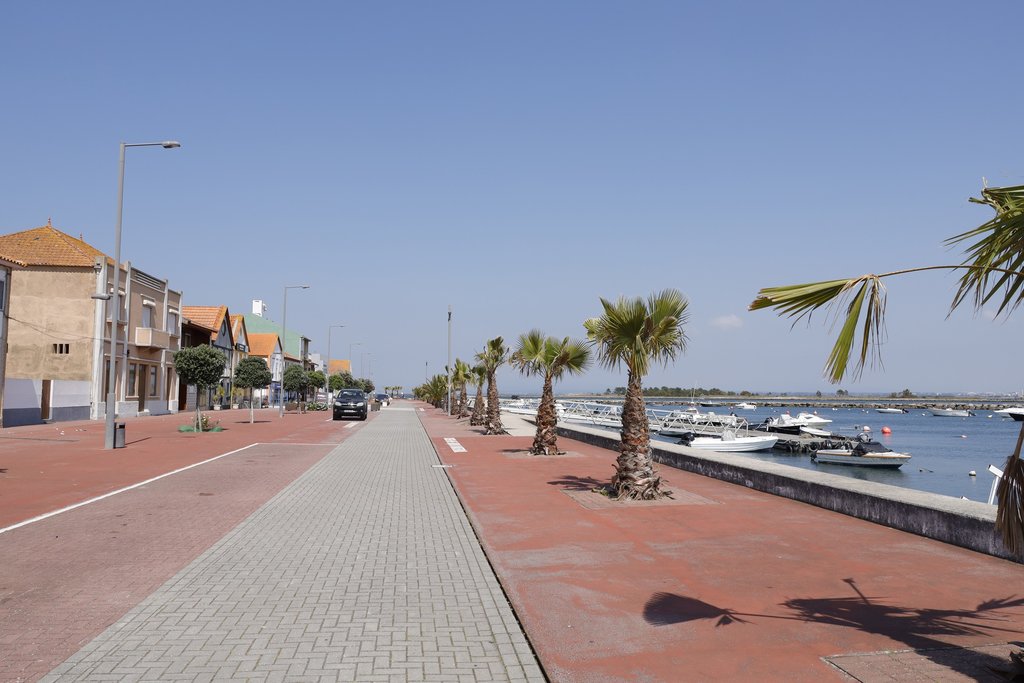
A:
[[510, 330, 590, 456]]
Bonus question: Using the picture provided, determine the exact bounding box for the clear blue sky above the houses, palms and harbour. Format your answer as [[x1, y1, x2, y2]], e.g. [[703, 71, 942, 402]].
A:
[[0, 0, 1024, 393]]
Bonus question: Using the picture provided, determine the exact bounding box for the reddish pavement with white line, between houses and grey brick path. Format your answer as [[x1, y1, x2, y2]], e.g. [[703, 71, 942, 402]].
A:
[[0, 411, 374, 681]]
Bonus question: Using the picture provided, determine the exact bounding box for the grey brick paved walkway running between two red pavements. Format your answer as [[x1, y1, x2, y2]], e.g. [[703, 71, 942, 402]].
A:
[[44, 409, 544, 681]]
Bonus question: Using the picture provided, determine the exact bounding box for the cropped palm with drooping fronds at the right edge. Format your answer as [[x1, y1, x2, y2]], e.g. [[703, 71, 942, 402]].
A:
[[750, 185, 1024, 556]]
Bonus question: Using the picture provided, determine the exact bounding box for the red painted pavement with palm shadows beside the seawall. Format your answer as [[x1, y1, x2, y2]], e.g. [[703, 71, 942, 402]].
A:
[[420, 409, 1024, 681]]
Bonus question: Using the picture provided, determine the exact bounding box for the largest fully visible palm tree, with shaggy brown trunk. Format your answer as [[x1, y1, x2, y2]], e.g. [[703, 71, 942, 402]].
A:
[[584, 289, 689, 500]]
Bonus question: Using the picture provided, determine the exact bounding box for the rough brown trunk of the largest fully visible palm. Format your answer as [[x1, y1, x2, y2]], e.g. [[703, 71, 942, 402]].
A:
[[611, 370, 670, 501]]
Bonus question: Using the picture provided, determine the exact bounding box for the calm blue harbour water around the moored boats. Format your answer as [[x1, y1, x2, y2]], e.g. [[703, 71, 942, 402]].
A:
[[651, 405, 1021, 503]]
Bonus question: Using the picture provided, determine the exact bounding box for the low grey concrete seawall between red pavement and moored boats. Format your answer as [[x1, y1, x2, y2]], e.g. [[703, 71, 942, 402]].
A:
[[558, 424, 1022, 562]]
